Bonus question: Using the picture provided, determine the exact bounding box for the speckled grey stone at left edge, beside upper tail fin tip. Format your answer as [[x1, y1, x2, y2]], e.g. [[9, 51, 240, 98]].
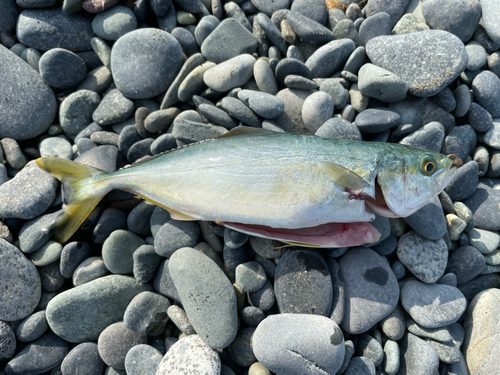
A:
[[0, 162, 58, 219]]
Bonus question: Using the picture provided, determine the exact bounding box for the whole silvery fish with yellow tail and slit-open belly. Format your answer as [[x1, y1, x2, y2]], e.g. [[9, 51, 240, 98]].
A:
[[36, 127, 457, 248]]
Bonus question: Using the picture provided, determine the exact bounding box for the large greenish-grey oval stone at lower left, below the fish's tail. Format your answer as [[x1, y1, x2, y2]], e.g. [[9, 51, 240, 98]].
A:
[[46, 275, 151, 343]]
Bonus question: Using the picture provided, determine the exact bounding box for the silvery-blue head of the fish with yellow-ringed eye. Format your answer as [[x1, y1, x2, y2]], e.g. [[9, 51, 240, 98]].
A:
[[368, 145, 460, 217]]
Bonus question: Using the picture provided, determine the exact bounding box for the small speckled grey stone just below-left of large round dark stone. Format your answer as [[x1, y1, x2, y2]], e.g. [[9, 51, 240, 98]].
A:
[[92, 89, 135, 126]]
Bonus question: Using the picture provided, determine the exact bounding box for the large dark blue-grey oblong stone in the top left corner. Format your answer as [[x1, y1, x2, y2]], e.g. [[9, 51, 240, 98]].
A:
[[16, 8, 94, 52]]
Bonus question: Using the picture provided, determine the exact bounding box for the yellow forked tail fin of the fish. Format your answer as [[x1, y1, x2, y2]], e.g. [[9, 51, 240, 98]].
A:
[[36, 157, 110, 243]]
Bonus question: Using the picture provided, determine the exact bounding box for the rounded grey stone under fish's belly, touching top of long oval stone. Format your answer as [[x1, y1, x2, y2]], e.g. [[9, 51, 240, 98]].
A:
[[154, 220, 200, 258]]
